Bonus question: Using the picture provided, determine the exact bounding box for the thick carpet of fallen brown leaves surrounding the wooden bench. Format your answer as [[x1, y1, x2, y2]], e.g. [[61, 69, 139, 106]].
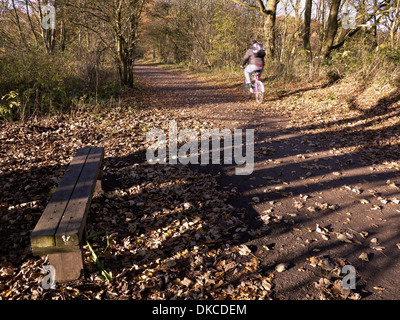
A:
[[0, 94, 284, 299]]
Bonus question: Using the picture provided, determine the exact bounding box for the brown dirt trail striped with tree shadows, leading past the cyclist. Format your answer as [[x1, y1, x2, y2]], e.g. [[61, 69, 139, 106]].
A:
[[136, 64, 400, 299]]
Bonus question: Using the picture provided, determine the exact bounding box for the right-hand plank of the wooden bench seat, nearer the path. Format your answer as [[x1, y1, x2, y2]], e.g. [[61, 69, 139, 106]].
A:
[[55, 147, 104, 251]]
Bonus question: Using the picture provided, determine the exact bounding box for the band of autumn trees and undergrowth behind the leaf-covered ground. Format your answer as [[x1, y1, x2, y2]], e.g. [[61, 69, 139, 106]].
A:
[[0, 0, 400, 120]]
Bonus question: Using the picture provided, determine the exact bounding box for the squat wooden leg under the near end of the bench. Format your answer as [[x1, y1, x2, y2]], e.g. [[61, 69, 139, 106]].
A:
[[49, 251, 83, 281]]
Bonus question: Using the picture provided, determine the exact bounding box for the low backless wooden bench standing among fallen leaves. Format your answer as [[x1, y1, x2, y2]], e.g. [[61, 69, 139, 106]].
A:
[[31, 147, 104, 281]]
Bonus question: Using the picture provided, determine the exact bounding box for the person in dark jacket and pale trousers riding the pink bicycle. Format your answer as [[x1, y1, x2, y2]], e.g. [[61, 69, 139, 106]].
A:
[[240, 40, 265, 89]]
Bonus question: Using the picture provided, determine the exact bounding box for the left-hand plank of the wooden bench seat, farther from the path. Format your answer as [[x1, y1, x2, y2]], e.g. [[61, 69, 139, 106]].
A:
[[31, 147, 90, 255]]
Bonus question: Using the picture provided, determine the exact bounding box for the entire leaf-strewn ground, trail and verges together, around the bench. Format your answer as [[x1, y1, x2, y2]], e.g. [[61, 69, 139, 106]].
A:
[[0, 63, 400, 300]]
